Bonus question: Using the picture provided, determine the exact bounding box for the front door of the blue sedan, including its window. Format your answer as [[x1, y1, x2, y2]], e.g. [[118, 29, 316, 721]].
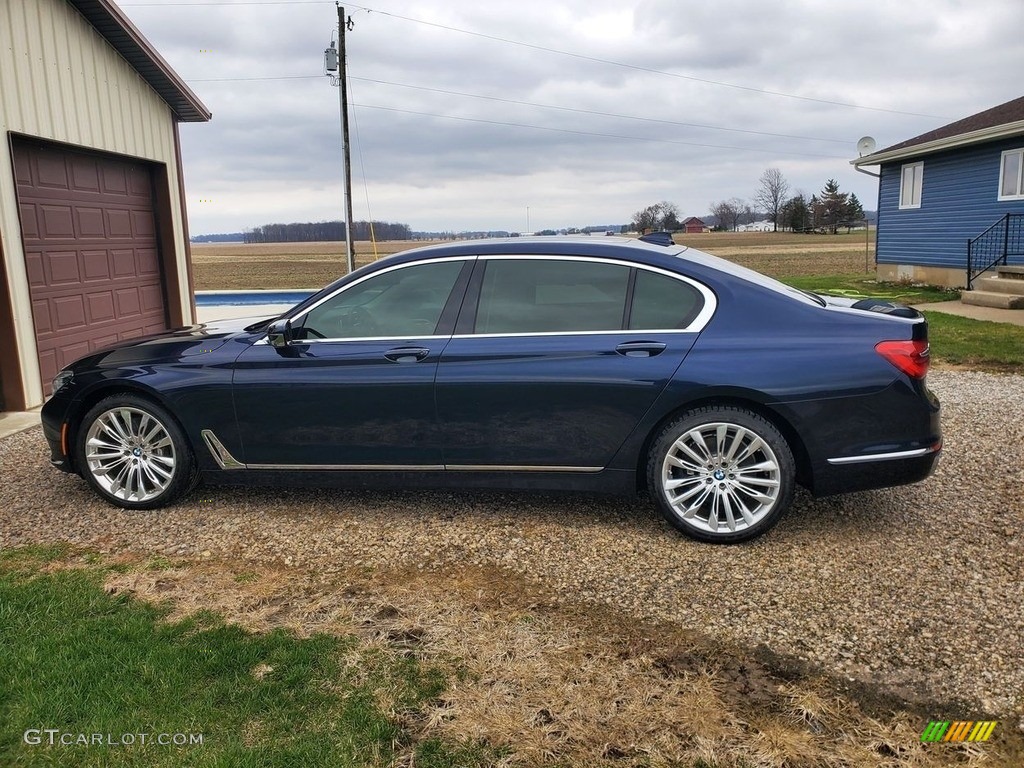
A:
[[232, 258, 472, 469]]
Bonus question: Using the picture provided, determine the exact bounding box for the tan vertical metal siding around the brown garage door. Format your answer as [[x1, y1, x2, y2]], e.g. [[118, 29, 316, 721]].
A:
[[0, 0, 191, 404]]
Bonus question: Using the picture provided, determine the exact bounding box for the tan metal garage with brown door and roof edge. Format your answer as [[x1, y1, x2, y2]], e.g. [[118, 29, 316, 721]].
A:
[[0, 0, 210, 411]]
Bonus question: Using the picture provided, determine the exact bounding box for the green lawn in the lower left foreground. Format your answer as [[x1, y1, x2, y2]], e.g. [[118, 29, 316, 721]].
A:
[[0, 547, 494, 768]]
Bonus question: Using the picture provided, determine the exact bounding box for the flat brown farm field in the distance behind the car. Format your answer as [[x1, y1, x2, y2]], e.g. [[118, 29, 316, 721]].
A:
[[191, 232, 874, 291]]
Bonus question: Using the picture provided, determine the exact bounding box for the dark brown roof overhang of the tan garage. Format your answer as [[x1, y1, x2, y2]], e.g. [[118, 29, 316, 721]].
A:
[[68, 0, 211, 123]]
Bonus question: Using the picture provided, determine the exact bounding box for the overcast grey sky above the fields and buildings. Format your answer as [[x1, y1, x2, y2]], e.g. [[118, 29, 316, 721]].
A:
[[121, 0, 1024, 234]]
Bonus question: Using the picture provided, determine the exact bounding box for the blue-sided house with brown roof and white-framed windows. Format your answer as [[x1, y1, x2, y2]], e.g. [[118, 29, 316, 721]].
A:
[[851, 97, 1024, 308]]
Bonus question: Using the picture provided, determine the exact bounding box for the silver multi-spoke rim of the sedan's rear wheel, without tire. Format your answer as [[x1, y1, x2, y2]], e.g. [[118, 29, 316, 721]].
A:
[[662, 422, 782, 534]]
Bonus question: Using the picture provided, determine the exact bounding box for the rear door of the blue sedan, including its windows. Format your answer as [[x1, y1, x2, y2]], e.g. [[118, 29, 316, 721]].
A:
[[436, 256, 715, 471]]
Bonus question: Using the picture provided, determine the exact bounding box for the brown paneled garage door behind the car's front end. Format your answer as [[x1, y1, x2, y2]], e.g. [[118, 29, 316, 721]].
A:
[[13, 139, 167, 394]]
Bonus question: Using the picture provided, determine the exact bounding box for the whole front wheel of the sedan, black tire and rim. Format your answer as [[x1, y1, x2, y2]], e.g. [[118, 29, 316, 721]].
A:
[[75, 393, 199, 509]]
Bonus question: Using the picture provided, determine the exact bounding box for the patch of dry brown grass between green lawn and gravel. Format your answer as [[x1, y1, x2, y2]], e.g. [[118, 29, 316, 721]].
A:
[[94, 558, 1011, 768]]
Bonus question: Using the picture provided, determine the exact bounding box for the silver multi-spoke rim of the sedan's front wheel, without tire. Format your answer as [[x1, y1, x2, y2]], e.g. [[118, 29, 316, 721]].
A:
[[85, 406, 175, 502]]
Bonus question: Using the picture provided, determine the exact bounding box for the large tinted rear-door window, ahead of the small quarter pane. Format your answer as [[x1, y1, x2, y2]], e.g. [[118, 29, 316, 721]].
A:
[[475, 259, 630, 334]]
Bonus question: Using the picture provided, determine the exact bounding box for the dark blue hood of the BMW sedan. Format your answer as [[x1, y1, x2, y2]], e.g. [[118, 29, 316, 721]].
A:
[[67, 317, 262, 368]]
